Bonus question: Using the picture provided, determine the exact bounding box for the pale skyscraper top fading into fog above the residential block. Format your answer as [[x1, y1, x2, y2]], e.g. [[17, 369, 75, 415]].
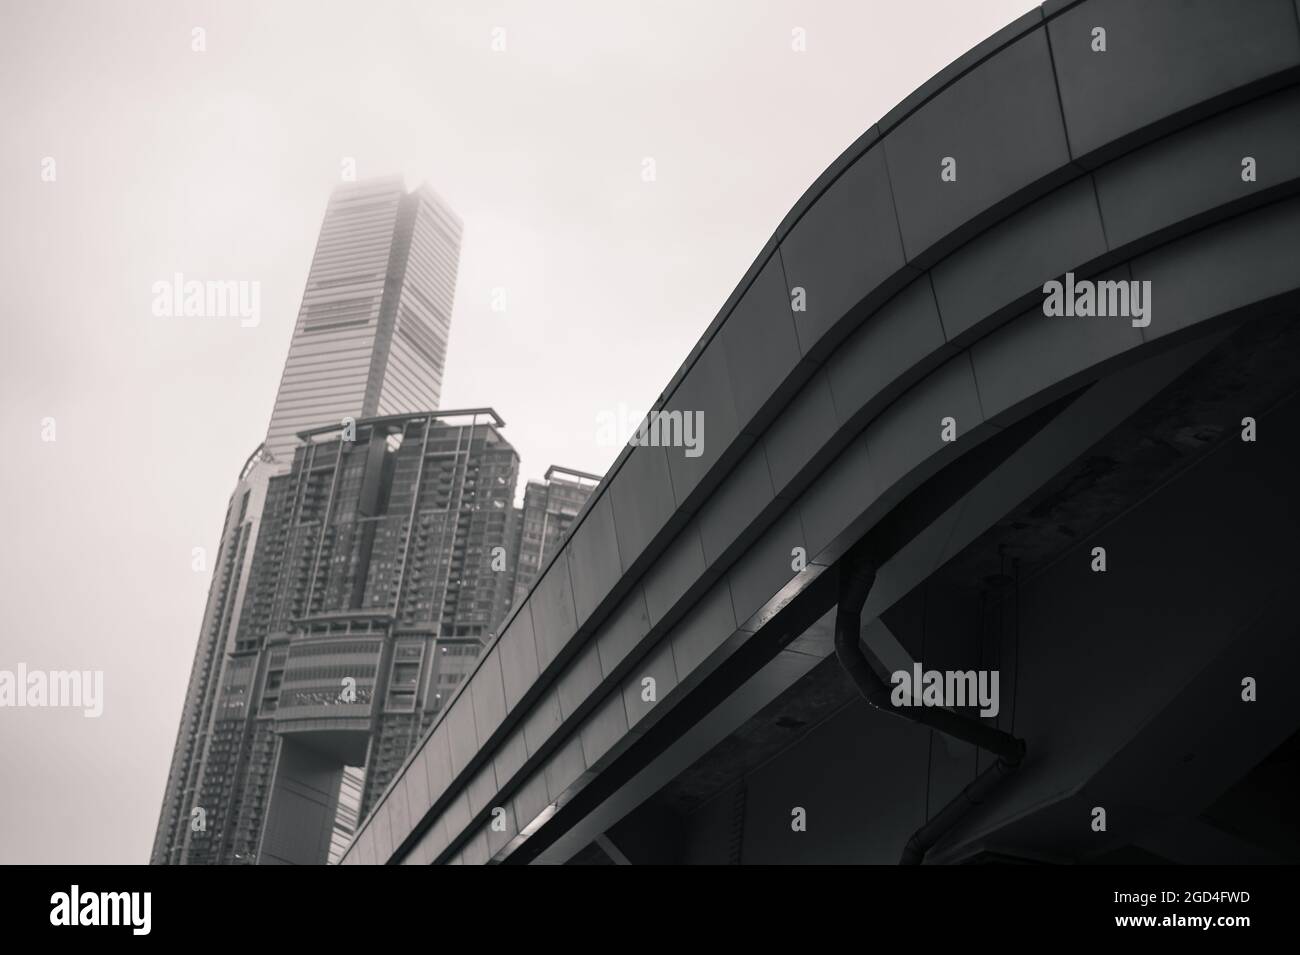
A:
[[267, 177, 462, 461]]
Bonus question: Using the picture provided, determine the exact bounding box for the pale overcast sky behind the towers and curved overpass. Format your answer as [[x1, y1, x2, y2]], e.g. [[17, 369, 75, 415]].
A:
[[0, 0, 1034, 863]]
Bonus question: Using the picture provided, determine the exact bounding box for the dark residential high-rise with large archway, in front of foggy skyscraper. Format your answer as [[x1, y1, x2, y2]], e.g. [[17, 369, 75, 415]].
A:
[[155, 408, 519, 863]]
